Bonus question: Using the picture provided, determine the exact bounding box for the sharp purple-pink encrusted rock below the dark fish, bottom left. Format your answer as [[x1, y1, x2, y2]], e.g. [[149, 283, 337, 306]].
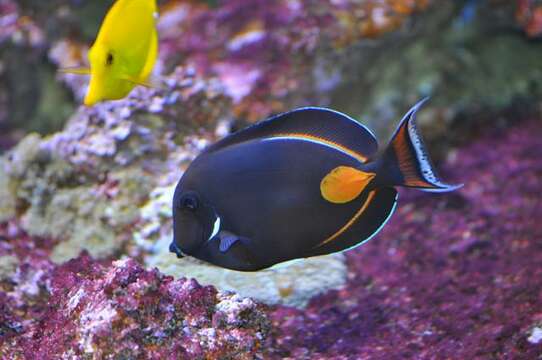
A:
[[0, 223, 270, 359]]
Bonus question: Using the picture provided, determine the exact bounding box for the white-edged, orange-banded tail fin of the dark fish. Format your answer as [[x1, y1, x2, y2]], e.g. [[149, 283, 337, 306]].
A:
[[382, 98, 463, 192]]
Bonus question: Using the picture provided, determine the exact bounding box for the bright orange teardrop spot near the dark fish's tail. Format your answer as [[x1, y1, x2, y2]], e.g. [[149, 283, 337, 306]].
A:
[[320, 166, 375, 204]]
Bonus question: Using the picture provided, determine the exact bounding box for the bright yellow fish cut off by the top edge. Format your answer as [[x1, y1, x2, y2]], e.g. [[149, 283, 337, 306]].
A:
[[61, 0, 158, 106]]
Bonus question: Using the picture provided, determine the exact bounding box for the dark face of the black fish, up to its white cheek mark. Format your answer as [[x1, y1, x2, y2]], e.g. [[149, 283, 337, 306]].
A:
[[172, 189, 220, 255]]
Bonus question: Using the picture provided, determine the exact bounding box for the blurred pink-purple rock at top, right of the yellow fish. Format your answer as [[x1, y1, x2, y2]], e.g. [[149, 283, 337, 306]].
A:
[[159, 0, 430, 121]]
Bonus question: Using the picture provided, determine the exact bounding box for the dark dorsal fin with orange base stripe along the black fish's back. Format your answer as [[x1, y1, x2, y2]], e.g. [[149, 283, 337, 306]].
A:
[[204, 107, 378, 162]]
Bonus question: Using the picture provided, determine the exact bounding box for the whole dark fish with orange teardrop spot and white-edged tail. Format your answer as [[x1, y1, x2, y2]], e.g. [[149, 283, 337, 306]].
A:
[[170, 101, 459, 271]]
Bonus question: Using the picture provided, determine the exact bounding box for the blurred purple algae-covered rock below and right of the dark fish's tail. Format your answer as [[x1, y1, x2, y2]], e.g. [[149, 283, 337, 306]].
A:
[[272, 122, 542, 359]]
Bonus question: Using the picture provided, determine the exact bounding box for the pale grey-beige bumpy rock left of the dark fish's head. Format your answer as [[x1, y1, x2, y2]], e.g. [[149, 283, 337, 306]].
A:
[[0, 67, 230, 262]]
